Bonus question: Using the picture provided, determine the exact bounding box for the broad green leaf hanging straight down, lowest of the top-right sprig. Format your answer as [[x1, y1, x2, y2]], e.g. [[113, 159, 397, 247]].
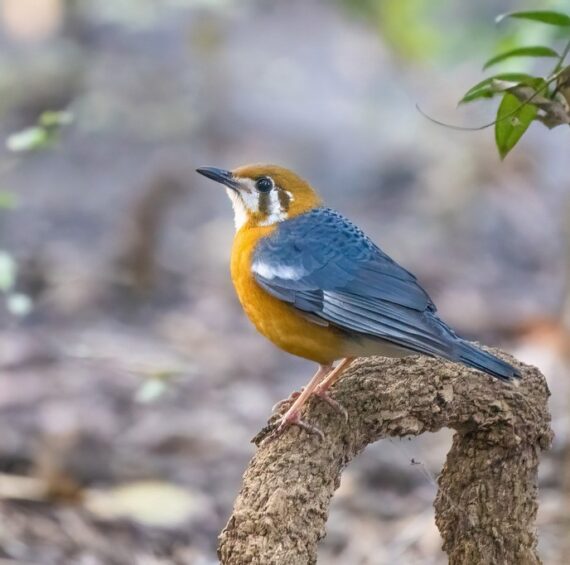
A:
[[495, 92, 538, 159]]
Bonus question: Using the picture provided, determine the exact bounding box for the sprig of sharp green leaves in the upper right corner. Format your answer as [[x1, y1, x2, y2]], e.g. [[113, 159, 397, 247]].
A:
[[460, 10, 570, 159]]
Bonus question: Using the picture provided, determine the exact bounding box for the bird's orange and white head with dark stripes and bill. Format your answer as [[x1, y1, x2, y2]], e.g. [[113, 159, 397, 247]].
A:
[[197, 165, 321, 229]]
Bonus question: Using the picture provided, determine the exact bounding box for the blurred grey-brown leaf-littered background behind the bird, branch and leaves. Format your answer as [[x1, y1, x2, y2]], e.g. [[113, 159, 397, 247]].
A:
[[0, 0, 570, 565]]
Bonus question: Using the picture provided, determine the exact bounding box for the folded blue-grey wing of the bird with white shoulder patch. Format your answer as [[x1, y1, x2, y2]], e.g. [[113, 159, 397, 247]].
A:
[[252, 208, 455, 355]]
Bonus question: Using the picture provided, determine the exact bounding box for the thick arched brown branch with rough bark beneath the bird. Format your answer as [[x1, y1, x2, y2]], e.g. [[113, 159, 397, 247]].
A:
[[218, 352, 552, 565]]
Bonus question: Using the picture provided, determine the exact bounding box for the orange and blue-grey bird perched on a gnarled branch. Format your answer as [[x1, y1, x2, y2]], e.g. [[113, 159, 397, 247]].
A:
[[196, 164, 521, 437]]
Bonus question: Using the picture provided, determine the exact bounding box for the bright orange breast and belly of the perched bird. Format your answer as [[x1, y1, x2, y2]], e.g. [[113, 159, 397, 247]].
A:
[[231, 226, 345, 364]]
